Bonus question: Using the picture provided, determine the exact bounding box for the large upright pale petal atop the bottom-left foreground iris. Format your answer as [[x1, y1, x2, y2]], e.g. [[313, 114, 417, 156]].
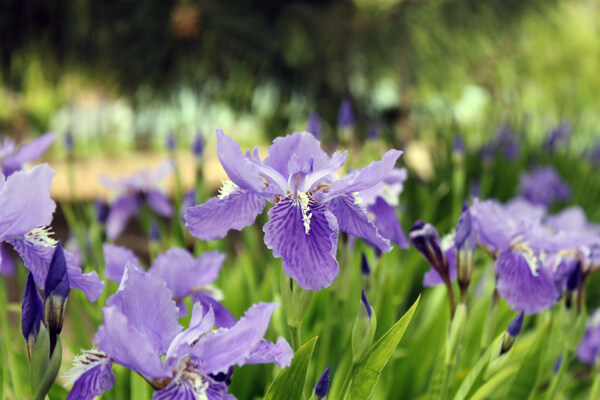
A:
[[105, 264, 182, 356]]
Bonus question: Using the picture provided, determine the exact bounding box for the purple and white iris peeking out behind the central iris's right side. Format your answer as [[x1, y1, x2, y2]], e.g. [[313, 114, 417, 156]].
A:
[[355, 168, 408, 249]]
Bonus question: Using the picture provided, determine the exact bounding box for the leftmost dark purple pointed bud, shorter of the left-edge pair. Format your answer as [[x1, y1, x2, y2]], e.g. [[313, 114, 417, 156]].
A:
[[21, 272, 44, 360]]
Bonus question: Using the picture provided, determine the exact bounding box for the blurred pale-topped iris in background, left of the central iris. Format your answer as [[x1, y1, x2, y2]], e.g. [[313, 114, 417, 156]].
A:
[[100, 162, 174, 240]]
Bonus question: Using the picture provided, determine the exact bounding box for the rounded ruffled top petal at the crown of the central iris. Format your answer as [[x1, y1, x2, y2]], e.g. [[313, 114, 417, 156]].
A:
[[264, 132, 330, 176]]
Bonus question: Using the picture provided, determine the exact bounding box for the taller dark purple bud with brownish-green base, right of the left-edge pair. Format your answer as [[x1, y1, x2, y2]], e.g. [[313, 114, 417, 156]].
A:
[[44, 241, 70, 349]]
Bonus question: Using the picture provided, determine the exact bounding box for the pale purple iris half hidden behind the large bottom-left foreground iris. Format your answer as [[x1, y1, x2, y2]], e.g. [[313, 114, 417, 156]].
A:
[[103, 243, 235, 328]]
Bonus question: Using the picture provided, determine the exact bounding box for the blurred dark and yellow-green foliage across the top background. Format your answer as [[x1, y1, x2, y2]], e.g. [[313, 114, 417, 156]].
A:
[[0, 0, 600, 149]]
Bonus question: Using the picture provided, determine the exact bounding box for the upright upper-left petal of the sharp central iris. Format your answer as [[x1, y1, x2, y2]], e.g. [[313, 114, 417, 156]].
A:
[[217, 129, 265, 193]]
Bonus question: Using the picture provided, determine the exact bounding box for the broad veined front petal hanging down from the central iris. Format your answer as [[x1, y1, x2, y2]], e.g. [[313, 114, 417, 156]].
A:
[[263, 198, 339, 290]]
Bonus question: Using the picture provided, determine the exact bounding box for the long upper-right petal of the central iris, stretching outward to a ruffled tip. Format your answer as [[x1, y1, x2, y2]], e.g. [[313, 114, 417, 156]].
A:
[[327, 149, 402, 198]]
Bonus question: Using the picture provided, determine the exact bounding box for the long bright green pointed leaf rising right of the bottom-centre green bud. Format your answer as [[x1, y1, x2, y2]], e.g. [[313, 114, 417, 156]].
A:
[[346, 296, 421, 400]]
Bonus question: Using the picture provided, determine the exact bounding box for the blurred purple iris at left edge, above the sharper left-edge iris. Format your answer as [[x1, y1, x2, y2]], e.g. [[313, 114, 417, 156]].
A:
[[0, 132, 56, 176]]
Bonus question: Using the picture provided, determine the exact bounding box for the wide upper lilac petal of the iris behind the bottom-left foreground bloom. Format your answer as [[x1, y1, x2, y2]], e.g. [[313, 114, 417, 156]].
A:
[[149, 247, 225, 298]]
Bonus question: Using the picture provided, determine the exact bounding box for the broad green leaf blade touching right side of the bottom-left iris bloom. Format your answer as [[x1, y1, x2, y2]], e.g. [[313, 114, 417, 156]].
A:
[[265, 337, 318, 400]]
